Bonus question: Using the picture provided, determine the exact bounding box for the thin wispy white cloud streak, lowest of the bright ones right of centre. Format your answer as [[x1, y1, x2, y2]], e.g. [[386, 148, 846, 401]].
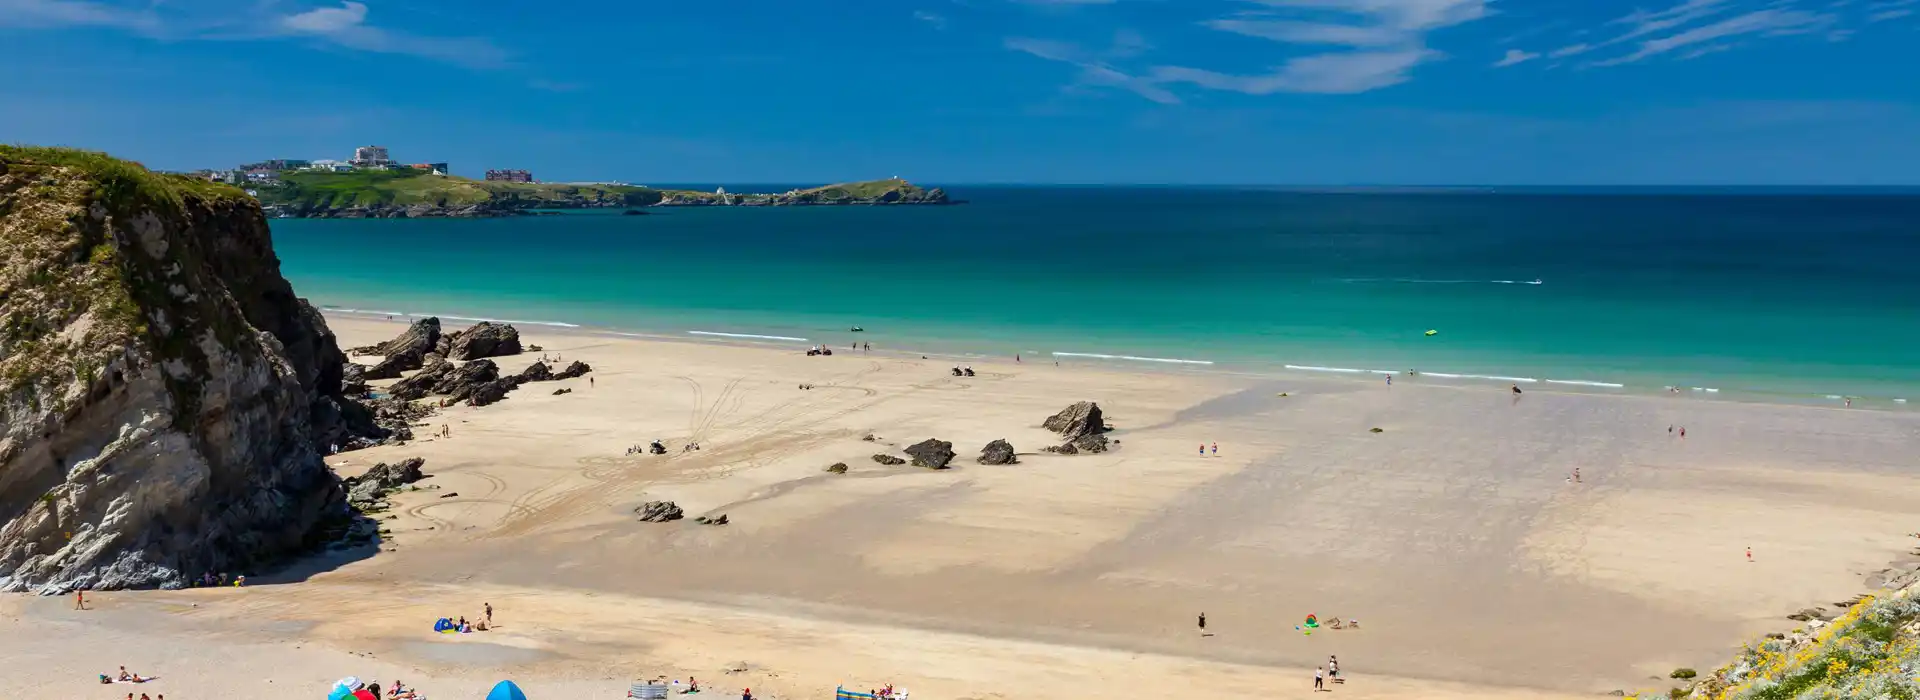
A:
[[1152, 48, 1434, 94]]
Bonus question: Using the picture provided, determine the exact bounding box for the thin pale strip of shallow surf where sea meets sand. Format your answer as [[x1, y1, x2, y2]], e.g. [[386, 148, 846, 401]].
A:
[[319, 305, 1912, 412]]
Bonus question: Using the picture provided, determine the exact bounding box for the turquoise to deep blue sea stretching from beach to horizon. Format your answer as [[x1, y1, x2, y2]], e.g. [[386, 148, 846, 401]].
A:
[[273, 188, 1920, 407]]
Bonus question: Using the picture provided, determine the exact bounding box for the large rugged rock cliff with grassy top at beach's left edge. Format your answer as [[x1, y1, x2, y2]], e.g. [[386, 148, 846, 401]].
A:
[[0, 146, 369, 593]]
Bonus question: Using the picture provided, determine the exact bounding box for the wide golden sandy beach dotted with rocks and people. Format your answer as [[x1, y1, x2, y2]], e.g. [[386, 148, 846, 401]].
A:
[[0, 315, 1920, 698]]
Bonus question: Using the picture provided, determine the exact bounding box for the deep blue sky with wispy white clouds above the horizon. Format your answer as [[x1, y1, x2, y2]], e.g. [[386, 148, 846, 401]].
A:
[[0, 0, 1920, 184]]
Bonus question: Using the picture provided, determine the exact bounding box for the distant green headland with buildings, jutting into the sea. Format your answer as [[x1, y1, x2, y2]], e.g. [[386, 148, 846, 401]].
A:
[[250, 169, 958, 219]]
